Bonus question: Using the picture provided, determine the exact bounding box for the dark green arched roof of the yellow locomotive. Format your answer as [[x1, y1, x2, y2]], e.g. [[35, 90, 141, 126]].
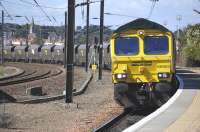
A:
[[114, 18, 169, 33]]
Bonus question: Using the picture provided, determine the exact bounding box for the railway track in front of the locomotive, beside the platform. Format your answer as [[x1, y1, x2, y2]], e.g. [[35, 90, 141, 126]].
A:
[[93, 108, 156, 132]]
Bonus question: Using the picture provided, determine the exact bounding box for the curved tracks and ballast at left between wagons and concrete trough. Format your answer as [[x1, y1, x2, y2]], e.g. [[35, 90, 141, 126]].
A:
[[0, 63, 92, 103]]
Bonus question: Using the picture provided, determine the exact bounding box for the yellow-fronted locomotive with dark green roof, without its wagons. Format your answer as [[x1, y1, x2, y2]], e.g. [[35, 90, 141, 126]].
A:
[[110, 18, 176, 107]]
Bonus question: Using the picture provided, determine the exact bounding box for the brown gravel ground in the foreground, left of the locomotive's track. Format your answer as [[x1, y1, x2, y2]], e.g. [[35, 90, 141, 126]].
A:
[[0, 71, 123, 132]]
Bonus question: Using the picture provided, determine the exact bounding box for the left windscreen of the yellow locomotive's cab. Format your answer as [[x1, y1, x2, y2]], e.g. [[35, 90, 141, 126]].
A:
[[115, 37, 139, 55]]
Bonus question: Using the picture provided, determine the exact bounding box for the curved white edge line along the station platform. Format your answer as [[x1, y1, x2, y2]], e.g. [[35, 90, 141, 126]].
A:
[[123, 76, 184, 132]]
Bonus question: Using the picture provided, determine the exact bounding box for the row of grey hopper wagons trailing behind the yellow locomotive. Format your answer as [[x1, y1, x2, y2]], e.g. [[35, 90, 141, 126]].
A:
[[3, 43, 111, 67]]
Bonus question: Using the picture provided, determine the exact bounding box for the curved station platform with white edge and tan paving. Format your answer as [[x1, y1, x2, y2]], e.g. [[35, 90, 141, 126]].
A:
[[124, 67, 200, 132]]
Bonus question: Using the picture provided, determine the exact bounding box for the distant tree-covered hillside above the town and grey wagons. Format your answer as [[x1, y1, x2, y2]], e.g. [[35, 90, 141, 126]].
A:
[[0, 23, 112, 44]]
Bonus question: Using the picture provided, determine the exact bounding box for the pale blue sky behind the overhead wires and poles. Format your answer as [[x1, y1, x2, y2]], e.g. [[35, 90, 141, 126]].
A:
[[0, 0, 200, 31]]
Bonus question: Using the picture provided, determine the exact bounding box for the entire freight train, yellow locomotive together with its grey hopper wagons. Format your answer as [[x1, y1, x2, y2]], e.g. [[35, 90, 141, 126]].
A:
[[4, 18, 176, 107]]
